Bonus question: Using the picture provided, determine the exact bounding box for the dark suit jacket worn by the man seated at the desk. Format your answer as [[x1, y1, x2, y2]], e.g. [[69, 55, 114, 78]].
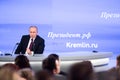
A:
[[15, 35, 45, 54]]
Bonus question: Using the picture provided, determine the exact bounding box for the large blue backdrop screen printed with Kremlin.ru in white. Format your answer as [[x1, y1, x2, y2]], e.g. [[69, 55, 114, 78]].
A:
[[0, 0, 120, 54]]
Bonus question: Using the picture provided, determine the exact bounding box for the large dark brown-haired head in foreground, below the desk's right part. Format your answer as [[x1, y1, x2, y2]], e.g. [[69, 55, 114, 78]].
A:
[[69, 61, 94, 80]]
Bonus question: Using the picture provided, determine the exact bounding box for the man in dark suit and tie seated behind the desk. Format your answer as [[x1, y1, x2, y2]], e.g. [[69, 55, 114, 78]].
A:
[[15, 26, 45, 55]]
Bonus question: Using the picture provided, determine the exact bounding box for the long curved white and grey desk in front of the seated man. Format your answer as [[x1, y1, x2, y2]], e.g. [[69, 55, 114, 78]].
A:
[[0, 52, 113, 72]]
